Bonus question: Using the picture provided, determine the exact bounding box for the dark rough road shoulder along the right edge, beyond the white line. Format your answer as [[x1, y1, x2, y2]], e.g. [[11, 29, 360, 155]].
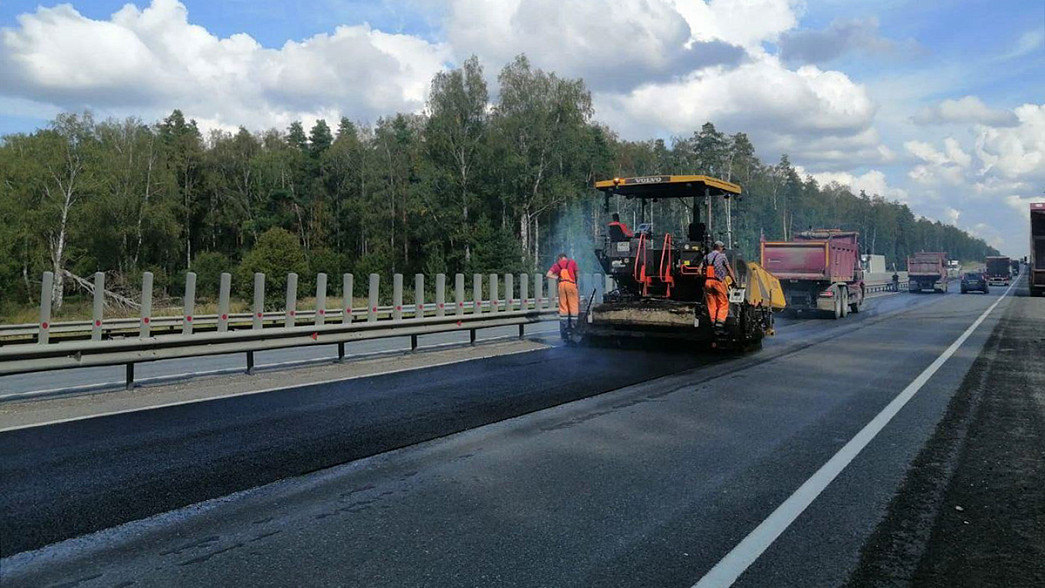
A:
[[849, 298, 1045, 587]]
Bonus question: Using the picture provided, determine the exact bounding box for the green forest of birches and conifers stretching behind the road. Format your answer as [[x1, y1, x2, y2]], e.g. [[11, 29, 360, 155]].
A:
[[0, 55, 996, 311]]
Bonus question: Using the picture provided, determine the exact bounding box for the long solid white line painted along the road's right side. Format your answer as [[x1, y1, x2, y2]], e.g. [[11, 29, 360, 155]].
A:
[[694, 283, 1015, 588]]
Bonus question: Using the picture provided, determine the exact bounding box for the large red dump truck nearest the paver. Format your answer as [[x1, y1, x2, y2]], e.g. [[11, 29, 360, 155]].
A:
[[762, 229, 864, 319]]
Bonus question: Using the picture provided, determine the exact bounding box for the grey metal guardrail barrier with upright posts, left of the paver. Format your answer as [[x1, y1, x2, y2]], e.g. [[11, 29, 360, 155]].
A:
[[0, 273, 608, 387]]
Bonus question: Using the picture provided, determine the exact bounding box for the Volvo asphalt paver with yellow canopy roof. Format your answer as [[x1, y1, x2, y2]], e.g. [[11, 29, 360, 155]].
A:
[[572, 175, 785, 350]]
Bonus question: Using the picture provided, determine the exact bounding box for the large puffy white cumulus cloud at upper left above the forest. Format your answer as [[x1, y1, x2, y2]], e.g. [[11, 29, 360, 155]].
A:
[[0, 0, 450, 126]]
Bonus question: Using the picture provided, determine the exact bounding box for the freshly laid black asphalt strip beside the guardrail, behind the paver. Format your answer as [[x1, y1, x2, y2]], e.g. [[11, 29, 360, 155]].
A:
[[0, 348, 715, 556]]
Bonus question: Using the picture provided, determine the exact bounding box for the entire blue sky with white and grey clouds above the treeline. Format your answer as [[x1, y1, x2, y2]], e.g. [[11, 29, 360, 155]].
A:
[[0, 0, 1045, 255]]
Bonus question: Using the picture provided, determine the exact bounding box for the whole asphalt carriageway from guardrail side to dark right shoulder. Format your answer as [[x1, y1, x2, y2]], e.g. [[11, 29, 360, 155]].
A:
[[0, 281, 1028, 586]]
